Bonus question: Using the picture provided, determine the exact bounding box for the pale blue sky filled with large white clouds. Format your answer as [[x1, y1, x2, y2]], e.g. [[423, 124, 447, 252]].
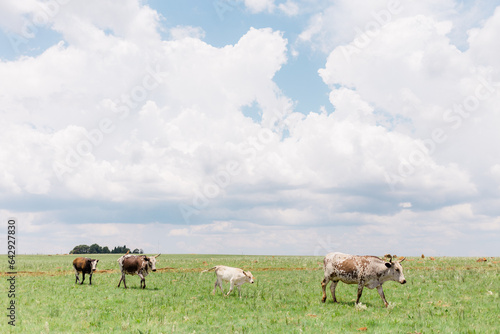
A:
[[0, 0, 500, 256]]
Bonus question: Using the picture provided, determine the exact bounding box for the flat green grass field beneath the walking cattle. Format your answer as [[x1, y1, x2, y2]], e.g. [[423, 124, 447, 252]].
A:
[[0, 254, 500, 333]]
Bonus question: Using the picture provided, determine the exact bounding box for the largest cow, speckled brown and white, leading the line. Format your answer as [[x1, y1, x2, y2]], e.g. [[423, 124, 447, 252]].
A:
[[321, 253, 406, 307]]
